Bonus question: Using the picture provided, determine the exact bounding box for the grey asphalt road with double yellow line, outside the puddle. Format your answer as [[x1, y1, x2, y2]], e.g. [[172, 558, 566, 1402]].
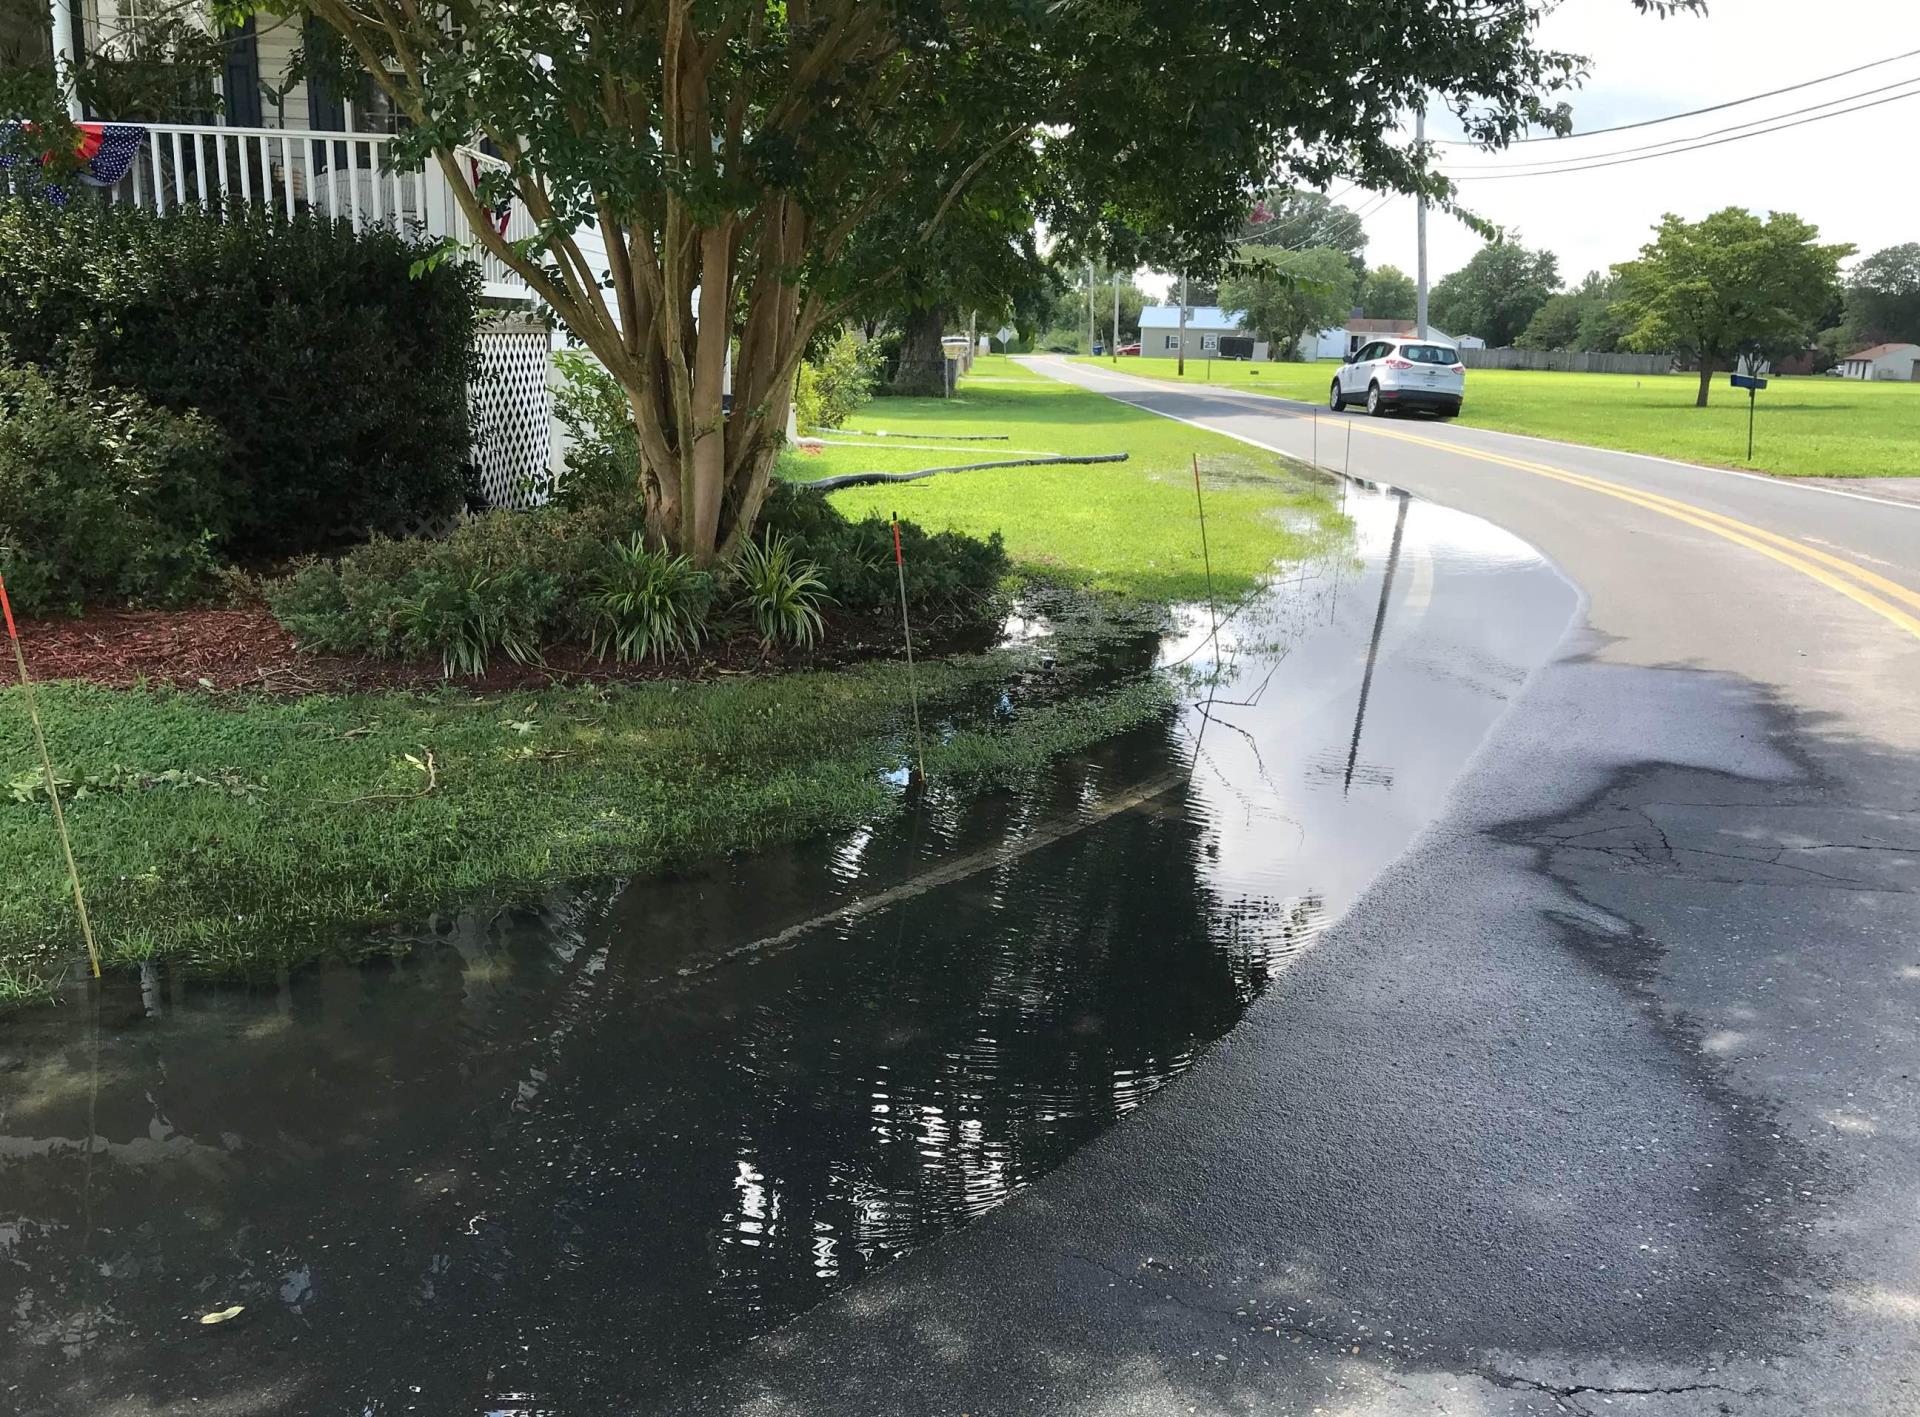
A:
[[674, 361, 1920, 1417]]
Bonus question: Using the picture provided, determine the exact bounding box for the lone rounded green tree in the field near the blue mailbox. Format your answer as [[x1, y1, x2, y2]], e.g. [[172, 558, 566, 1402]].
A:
[[1613, 207, 1853, 409]]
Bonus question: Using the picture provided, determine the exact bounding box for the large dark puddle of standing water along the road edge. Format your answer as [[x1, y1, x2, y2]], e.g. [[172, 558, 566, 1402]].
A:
[[0, 486, 1574, 1413]]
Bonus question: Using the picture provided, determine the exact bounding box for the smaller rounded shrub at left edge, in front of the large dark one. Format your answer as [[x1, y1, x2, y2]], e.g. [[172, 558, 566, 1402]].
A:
[[0, 363, 225, 611]]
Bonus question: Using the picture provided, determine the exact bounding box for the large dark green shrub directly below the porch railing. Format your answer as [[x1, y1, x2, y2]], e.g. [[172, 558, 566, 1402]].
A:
[[0, 202, 478, 557]]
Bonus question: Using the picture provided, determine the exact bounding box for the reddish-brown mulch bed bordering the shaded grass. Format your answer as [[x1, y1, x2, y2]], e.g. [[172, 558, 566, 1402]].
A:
[[19, 605, 917, 695]]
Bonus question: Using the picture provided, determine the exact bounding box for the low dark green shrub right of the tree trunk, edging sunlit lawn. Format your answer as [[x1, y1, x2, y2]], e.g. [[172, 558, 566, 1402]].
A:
[[762, 484, 1008, 624]]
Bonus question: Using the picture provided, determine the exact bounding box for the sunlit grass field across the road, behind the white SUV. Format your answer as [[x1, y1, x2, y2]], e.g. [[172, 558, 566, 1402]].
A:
[[1077, 359, 1920, 478]]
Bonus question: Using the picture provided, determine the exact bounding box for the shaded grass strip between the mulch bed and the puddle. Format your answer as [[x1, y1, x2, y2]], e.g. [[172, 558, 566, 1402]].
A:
[[0, 643, 1169, 1002]]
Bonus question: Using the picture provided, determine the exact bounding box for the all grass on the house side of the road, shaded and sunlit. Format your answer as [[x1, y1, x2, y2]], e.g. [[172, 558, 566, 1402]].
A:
[[0, 359, 1344, 1002]]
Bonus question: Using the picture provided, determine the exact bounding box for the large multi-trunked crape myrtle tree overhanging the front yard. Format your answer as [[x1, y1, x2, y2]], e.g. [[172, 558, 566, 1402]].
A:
[[215, 0, 1697, 561]]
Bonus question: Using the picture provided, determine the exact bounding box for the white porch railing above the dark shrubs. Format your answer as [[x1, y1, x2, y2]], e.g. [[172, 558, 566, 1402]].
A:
[[80, 123, 534, 300]]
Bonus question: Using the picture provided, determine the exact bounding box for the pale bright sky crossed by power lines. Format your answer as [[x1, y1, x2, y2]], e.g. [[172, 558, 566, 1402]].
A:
[[1142, 0, 1920, 295]]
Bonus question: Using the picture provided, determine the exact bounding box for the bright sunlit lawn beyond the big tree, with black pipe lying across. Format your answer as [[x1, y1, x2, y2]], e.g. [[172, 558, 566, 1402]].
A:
[[781, 355, 1344, 601]]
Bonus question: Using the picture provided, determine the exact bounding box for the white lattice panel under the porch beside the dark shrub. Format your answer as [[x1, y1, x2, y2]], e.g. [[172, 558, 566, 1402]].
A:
[[468, 319, 553, 511]]
